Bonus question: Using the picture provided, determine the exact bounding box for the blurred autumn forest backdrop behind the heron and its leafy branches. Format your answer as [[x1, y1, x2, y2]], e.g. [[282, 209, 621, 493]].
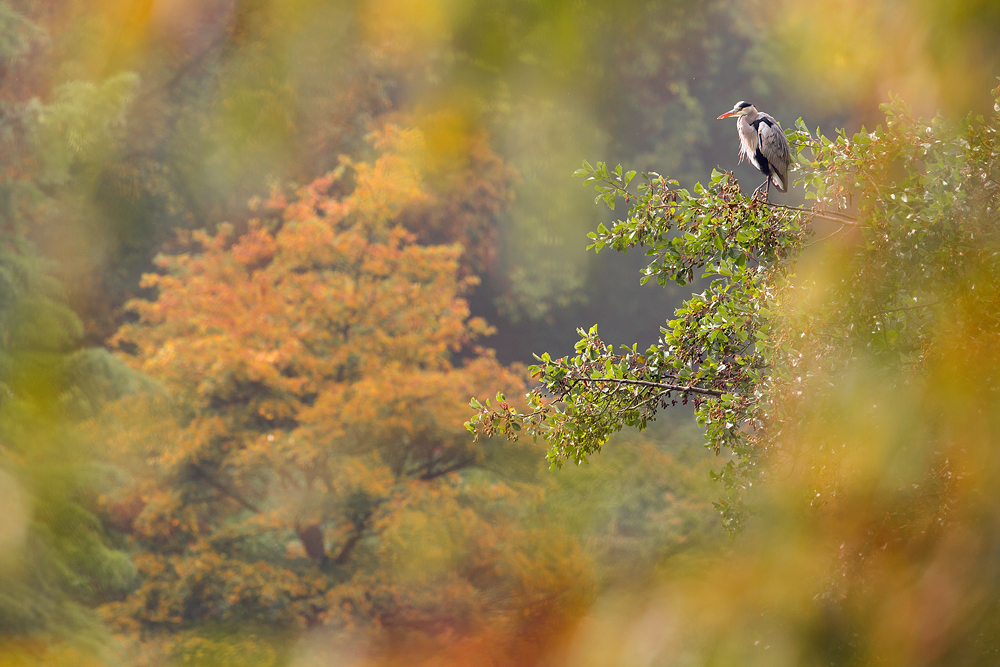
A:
[[0, 0, 1000, 665]]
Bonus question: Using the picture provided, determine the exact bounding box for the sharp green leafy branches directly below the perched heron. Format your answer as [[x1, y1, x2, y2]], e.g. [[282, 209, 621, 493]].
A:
[[468, 163, 805, 532]]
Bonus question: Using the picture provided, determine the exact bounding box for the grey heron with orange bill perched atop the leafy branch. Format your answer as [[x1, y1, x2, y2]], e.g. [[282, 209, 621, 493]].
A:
[[718, 102, 792, 197]]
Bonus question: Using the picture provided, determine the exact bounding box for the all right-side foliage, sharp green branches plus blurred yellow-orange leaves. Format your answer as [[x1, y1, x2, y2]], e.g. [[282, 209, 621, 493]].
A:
[[469, 89, 1000, 665]]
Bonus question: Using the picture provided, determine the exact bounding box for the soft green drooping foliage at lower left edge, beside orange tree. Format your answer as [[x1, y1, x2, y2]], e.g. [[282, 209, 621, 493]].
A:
[[0, 237, 135, 638]]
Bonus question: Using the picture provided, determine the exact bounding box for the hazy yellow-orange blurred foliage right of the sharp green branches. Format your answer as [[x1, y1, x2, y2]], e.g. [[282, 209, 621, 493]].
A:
[[648, 90, 1000, 665]]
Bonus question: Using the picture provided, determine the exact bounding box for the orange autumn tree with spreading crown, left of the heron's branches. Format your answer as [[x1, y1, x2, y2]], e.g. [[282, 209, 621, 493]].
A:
[[95, 126, 588, 655]]
